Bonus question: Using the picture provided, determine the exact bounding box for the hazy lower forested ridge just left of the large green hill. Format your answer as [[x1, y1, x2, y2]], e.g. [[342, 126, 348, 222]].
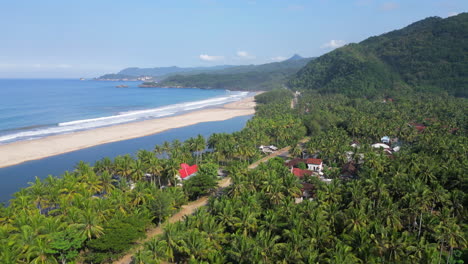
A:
[[159, 55, 312, 90]]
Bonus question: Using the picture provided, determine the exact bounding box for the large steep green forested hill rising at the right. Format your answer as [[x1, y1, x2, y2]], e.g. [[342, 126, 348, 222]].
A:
[[288, 13, 468, 97]]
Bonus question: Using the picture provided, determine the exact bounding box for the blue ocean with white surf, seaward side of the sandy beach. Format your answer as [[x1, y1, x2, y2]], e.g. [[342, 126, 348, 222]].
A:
[[0, 79, 249, 144]]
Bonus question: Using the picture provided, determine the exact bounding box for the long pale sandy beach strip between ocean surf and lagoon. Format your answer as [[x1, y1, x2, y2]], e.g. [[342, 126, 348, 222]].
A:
[[0, 97, 255, 168]]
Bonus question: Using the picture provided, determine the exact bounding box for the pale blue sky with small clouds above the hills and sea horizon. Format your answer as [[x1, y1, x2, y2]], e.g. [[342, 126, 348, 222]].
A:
[[0, 0, 468, 78]]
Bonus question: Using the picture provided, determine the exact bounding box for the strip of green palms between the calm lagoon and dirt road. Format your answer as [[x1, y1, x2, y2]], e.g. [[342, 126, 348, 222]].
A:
[[0, 91, 305, 264]]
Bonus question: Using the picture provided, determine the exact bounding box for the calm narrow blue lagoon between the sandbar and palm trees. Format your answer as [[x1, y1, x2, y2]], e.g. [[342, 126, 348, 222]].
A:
[[0, 116, 251, 204]]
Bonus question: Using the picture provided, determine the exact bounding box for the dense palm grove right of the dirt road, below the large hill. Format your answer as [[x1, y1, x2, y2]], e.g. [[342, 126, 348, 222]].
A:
[[135, 91, 468, 263]]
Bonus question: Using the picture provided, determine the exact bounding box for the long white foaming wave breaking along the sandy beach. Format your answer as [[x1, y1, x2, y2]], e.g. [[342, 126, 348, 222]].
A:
[[0, 92, 249, 144]]
